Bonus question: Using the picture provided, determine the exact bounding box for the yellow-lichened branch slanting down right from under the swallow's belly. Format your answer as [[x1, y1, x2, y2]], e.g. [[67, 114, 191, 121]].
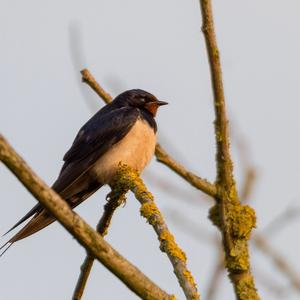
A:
[[113, 164, 200, 300]]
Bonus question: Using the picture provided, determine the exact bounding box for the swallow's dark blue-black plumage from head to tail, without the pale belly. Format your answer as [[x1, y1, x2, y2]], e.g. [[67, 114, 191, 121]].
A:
[[0, 89, 167, 254]]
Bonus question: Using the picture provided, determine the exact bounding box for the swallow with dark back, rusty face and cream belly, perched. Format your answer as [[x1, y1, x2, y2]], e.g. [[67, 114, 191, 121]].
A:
[[0, 89, 168, 255]]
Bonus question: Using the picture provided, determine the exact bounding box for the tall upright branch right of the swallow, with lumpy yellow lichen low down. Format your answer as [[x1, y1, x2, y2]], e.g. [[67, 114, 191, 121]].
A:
[[200, 0, 259, 300]]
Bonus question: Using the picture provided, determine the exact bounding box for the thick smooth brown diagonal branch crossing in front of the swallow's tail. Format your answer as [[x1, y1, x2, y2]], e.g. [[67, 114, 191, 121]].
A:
[[0, 135, 174, 300]]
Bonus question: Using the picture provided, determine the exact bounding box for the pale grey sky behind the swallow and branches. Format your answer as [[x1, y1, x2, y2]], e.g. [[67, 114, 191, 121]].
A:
[[0, 0, 300, 300]]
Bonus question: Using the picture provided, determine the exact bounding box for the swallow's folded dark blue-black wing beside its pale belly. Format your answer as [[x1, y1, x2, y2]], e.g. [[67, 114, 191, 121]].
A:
[[52, 107, 139, 193]]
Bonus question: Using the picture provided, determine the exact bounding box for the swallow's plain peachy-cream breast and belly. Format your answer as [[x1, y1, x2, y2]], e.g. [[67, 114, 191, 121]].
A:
[[92, 119, 156, 184]]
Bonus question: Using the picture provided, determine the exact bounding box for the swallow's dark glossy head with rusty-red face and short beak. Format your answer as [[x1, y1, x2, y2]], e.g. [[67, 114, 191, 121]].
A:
[[115, 89, 168, 117]]
